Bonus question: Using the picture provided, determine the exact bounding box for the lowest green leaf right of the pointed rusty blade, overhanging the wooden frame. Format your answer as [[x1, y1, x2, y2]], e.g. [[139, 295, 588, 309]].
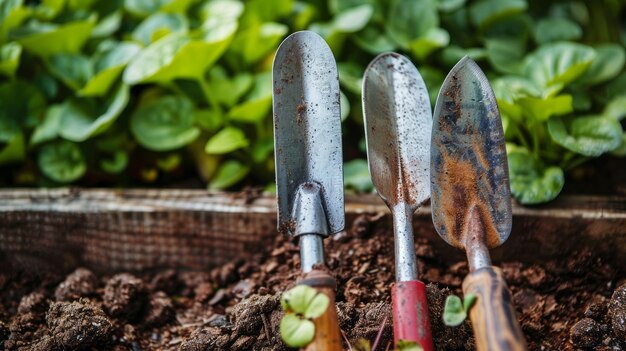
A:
[[508, 148, 565, 205]]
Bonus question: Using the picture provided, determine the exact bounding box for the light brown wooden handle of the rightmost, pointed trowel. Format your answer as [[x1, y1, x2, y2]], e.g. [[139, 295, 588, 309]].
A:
[[463, 267, 526, 351]]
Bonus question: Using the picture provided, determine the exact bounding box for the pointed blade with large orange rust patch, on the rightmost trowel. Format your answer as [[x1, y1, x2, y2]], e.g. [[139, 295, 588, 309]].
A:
[[431, 57, 511, 248]]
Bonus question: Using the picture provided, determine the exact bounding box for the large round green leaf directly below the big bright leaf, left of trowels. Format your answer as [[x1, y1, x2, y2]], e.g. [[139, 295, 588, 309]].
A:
[[130, 96, 200, 151]]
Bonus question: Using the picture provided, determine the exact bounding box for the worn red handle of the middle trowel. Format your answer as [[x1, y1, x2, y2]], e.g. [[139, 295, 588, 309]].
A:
[[391, 280, 434, 351]]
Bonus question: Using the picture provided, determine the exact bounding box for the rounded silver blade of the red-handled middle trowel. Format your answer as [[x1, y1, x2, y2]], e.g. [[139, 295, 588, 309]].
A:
[[363, 53, 432, 208]]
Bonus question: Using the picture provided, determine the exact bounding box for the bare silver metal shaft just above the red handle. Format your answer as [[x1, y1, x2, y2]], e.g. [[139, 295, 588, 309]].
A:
[[391, 202, 417, 282]]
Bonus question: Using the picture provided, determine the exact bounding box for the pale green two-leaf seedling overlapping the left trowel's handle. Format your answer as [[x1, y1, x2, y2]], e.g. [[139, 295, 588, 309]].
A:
[[280, 285, 330, 347]]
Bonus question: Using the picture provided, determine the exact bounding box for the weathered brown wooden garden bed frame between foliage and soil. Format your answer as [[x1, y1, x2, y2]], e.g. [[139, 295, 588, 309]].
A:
[[0, 188, 626, 272]]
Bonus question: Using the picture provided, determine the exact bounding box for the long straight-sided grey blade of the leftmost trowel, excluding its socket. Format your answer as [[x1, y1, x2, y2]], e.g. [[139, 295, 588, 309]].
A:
[[272, 31, 345, 238]]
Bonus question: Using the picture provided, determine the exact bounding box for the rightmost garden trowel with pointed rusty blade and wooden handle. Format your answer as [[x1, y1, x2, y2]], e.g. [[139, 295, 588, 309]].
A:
[[430, 57, 526, 351]]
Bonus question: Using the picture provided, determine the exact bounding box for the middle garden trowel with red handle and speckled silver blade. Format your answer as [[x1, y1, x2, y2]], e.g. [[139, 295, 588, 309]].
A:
[[363, 53, 433, 351]]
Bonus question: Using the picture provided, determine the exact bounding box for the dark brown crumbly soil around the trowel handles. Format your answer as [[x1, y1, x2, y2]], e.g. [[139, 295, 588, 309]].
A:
[[0, 215, 626, 351]]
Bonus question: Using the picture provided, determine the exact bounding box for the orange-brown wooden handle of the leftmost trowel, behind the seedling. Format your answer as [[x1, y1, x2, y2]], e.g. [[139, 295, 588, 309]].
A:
[[300, 270, 343, 351]]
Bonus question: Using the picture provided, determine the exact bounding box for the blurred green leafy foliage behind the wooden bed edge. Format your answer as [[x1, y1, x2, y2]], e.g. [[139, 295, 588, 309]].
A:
[[0, 0, 626, 204]]
